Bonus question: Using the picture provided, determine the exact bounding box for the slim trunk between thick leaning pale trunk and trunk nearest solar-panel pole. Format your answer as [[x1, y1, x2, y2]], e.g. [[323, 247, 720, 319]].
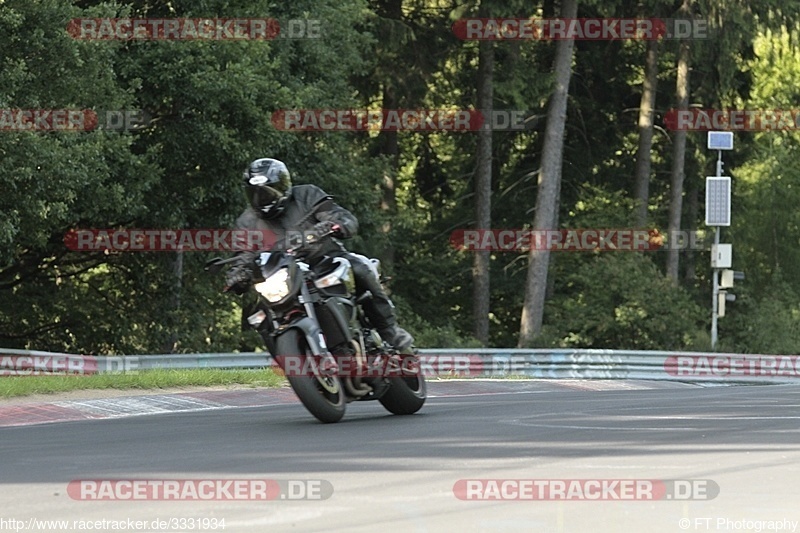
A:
[[634, 39, 659, 227]]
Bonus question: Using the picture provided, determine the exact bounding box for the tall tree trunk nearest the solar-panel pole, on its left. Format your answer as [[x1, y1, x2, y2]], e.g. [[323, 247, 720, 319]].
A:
[[667, 17, 691, 285]]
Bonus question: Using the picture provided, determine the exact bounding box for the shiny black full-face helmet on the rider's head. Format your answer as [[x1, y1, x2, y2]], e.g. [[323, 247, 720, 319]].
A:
[[244, 158, 292, 218]]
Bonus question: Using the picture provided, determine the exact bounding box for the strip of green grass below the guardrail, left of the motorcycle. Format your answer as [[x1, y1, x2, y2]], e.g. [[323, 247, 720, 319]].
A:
[[0, 369, 285, 398]]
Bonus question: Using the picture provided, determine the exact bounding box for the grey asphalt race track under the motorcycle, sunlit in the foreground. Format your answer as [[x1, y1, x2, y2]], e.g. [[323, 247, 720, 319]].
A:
[[0, 381, 800, 532]]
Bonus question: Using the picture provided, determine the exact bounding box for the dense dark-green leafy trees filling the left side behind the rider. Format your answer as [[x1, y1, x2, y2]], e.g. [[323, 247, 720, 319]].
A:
[[0, 0, 380, 353]]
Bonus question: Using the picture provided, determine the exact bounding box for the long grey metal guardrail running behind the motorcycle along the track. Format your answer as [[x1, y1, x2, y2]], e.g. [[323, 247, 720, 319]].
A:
[[0, 348, 800, 383]]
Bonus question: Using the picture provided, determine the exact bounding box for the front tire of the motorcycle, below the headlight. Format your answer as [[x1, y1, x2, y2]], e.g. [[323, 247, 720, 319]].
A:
[[275, 329, 347, 424]]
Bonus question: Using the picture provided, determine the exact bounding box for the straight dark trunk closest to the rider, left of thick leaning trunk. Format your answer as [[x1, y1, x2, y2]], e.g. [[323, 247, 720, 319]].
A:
[[472, 41, 494, 344]]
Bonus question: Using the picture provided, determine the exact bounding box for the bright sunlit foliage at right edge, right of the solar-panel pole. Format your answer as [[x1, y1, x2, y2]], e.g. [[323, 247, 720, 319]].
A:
[[720, 28, 800, 354]]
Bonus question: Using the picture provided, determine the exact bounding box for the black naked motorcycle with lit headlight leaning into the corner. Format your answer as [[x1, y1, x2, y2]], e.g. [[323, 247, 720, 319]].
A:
[[206, 222, 427, 423]]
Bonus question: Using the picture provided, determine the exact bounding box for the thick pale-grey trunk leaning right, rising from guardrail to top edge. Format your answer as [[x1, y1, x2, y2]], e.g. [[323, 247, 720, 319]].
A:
[[519, 0, 578, 348]]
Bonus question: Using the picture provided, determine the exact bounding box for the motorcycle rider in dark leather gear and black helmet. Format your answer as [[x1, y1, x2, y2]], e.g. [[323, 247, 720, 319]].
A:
[[226, 158, 414, 353]]
